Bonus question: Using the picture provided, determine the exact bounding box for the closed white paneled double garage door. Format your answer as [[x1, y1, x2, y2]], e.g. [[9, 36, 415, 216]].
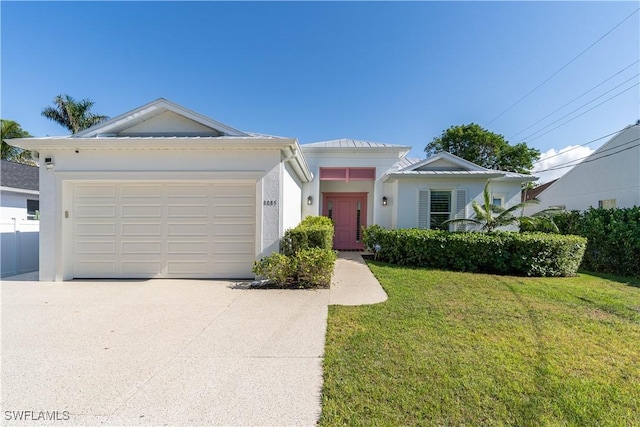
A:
[[72, 182, 256, 278]]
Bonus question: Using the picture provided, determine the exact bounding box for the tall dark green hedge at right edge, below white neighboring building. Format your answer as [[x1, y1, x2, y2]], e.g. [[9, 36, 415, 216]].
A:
[[553, 206, 640, 277]]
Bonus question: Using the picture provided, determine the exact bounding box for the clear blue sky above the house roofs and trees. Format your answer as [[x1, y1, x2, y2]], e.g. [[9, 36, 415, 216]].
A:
[[0, 1, 640, 181]]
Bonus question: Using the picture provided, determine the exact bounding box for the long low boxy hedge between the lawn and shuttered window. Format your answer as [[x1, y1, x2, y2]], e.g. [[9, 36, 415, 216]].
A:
[[363, 225, 586, 277]]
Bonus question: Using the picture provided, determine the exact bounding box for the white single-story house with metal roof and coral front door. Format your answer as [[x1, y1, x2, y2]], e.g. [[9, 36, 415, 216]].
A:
[[9, 99, 536, 281]]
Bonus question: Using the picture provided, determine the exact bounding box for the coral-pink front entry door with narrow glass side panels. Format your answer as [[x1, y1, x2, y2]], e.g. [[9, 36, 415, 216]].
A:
[[322, 193, 367, 250]]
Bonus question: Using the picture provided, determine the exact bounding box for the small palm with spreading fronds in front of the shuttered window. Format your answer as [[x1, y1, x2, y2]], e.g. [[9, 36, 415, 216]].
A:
[[443, 182, 561, 232]]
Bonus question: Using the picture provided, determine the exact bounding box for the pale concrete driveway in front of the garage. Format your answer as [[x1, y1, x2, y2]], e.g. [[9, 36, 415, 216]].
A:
[[1, 280, 329, 425]]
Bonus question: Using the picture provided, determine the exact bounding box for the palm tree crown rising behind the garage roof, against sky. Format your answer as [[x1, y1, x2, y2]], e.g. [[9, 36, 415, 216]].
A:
[[42, 95, 109, 133]]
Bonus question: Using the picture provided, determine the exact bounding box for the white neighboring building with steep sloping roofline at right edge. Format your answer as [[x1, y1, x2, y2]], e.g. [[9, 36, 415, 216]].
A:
[[527, 123, 640, 216]]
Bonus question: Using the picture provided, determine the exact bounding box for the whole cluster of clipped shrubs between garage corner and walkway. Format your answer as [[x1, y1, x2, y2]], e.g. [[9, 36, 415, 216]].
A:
[[253, 216, 337, 288]]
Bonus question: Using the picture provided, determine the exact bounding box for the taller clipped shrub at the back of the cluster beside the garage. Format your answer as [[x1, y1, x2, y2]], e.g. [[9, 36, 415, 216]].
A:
[[280, 216, 334, 256]]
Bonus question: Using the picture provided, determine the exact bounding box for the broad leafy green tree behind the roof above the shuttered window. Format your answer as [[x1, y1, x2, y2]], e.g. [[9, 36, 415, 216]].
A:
[[424, 123, 540, 174]]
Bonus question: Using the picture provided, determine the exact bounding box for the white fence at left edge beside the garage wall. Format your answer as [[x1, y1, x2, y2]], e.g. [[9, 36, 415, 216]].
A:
[[0, 220, 40, 277]]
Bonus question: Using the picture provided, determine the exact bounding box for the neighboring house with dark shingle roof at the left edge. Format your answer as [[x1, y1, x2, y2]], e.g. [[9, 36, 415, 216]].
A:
[[0, 160, 39, 223]]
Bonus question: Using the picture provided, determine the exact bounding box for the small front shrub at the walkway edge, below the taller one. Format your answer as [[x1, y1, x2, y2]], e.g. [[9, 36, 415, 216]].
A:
[[295, 248, 337, 288]]
